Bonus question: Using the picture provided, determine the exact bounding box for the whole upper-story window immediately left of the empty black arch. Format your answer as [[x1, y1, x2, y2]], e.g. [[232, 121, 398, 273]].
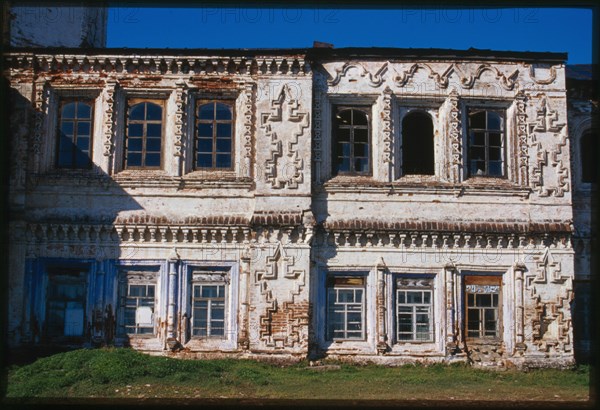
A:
[[332, 106, 371, 175]]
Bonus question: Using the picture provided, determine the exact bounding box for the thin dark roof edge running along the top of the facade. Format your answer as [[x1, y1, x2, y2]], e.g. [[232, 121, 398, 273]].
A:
[[5, 47, 567, 63]]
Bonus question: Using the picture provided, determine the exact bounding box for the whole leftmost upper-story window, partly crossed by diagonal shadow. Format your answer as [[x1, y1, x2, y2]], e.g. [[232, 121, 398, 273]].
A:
[[56, 99, 94, 169]]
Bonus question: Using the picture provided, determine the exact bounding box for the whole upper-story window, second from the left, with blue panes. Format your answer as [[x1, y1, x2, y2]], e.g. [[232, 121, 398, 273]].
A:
[[124, 99, 163, 169]]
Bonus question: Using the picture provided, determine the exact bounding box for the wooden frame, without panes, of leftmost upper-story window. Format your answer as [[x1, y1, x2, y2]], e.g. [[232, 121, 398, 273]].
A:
[[54, 95, 96, 170]]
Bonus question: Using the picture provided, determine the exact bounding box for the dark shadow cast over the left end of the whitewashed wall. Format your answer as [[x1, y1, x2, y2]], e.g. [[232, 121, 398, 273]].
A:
[[5, 87, 143, 361]]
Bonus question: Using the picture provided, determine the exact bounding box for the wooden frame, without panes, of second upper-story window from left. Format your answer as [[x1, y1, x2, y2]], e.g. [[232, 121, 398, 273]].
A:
[[121, 95, 167, 171]]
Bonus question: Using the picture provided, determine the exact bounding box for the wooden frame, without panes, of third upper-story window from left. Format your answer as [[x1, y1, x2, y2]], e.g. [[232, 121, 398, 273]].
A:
[[191, 99, 237, 173]]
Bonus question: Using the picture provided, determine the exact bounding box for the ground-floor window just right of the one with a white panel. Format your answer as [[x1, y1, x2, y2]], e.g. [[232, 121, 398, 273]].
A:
[[191, 268, 228, 338]]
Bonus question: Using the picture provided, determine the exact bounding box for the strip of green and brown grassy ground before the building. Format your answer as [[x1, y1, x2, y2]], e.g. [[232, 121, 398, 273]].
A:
[[6, 349, 589, 401]]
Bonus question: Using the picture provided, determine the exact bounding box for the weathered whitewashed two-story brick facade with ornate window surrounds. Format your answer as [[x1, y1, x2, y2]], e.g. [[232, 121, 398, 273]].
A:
[[4, 48, 575, 367]]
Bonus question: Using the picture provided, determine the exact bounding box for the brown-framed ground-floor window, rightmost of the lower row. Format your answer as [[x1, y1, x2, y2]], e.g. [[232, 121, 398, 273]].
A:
[[465, 275, 501, 339]]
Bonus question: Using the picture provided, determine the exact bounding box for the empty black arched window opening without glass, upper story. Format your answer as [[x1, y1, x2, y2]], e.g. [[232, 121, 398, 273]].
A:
[[402, 111, 435, 175]]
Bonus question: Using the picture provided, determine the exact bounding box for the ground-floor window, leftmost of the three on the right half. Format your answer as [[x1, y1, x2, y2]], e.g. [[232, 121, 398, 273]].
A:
[[327, 276, 365, 340]]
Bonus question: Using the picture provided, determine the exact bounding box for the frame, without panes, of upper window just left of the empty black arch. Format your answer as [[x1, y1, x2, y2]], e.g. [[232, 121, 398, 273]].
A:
[[331, 103, 374, 177]]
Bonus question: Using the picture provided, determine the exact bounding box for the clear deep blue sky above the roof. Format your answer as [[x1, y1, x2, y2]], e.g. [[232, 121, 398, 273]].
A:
[[107, 7, 592, 64]]
